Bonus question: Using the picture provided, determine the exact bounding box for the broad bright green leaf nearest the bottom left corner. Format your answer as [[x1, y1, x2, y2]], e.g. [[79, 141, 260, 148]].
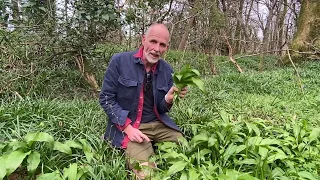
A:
[[6, 150, 31, 176]]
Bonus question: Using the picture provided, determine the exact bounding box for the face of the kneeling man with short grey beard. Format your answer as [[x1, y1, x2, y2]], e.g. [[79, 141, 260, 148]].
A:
[[142, 27, 169, 64]]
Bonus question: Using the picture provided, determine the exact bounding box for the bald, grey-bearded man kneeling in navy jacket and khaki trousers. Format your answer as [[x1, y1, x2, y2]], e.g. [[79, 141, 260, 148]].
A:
[[100, 24, 187, 178]]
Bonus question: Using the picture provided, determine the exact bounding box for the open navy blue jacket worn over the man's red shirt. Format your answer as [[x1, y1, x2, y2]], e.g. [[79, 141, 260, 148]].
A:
[[100, 49, 180, 148]]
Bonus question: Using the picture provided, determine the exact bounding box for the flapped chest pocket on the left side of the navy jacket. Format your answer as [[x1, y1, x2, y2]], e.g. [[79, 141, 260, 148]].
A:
[[117, 76, 138, 99]]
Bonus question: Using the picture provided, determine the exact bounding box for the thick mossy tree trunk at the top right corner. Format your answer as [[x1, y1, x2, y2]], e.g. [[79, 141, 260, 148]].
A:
[[283, 0, 320, 63]]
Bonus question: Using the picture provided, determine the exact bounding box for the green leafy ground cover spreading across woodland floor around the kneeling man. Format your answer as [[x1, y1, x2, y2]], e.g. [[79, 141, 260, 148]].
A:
[[0, 52, 320, 179]]
